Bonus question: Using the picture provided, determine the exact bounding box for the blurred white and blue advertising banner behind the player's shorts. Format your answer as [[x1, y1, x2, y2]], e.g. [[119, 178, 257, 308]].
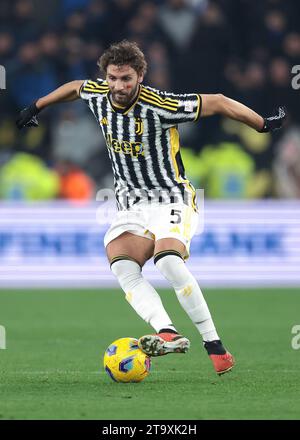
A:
[[0, 201, 300, 288]]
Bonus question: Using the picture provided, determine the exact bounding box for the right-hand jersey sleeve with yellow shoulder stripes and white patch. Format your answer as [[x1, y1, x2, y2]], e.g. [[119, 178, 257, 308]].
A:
[[141, 87, 202, 128]]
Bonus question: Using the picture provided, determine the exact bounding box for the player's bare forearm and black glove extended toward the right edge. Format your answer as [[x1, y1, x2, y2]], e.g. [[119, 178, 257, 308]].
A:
[[201, 94, 286, 133]]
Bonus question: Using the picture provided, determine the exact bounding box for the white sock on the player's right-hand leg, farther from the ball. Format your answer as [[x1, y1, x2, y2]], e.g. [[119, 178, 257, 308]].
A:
[[155, 254, 220, 341]]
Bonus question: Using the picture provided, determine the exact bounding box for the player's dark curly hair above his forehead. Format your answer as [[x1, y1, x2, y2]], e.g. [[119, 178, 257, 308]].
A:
[[97, 40, 147, 75]]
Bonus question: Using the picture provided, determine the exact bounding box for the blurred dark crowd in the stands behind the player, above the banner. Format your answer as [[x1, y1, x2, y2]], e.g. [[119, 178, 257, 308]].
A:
[[0, 0, 300, 200]]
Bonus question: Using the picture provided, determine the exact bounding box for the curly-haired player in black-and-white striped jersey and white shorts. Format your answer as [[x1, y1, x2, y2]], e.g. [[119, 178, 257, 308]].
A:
[[17, 40, 285, 375]]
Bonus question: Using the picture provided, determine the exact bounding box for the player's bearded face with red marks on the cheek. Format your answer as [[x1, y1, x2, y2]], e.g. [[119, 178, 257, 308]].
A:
[[106, 64, 143, 107]]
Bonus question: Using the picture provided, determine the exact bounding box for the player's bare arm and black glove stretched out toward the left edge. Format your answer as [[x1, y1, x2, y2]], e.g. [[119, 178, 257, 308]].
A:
[[16, 80, 84, 130]]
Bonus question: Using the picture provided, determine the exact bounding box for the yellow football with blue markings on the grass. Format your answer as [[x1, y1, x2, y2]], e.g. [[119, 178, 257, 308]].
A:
[[104, 338, 151, 382]]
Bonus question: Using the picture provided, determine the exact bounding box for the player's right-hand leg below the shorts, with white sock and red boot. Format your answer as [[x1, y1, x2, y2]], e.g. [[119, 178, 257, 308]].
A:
[[154, 238, 233, 374]]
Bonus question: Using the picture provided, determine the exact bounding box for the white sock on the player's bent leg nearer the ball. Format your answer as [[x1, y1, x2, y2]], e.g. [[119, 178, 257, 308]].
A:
[[111, 259, 176, 332]]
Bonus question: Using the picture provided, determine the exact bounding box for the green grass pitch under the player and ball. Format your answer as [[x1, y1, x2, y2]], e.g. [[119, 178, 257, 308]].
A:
[[0, 289, 300, 420]]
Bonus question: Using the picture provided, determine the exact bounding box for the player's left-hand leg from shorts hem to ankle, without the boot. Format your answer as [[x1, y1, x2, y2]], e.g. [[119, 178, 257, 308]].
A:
[[106, 232, 176, 332]]
